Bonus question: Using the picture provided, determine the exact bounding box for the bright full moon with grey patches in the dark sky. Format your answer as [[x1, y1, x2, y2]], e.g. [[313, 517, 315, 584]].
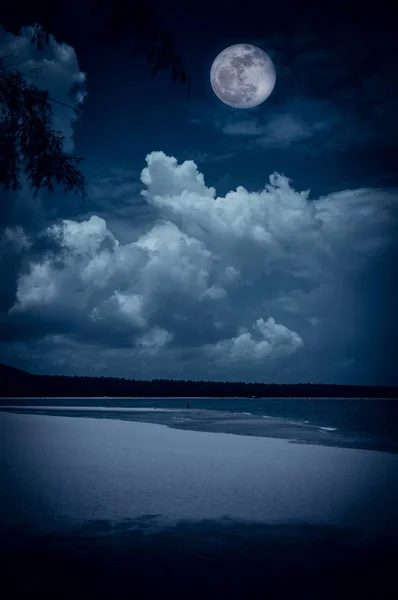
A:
[[210, 44, 276, 108]]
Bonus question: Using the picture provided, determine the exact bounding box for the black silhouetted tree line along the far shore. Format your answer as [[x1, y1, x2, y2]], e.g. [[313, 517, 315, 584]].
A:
[[0, 365, 398, 398]]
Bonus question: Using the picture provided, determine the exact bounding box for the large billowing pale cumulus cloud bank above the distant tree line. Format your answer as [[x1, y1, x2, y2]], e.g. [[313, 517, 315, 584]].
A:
[[3, 152, 396, 380]]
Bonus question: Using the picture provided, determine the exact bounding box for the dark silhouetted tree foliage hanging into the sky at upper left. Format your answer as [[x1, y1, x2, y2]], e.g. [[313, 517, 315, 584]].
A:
[[0, 0, 190, 197]]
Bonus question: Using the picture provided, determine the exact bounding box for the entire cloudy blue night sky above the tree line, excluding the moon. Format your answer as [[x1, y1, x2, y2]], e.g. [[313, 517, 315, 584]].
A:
[[0, 0, 398, 385]]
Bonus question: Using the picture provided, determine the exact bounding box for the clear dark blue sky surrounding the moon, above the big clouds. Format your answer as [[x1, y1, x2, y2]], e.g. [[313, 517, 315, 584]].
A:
[[54, 0, 398, 193]]
